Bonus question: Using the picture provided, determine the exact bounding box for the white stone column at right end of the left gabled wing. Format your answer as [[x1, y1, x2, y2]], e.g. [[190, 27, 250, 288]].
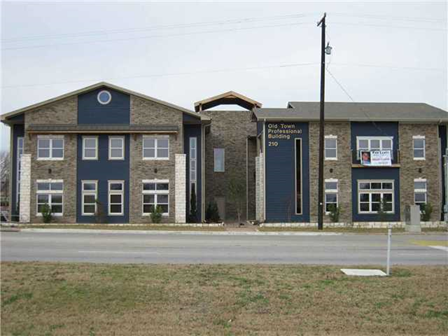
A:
[[175, 154, 187, 223]]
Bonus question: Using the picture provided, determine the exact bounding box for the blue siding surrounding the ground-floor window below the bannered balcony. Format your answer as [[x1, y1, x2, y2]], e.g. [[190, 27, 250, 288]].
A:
[[352, 168, 400, 222]]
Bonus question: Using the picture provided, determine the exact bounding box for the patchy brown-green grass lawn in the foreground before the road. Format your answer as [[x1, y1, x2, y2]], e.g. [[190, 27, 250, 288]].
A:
[[1, 262, 448, 335]]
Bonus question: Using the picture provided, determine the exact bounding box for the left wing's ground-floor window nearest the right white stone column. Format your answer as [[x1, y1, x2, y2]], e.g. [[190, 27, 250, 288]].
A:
[[143, 180, 170, 216]]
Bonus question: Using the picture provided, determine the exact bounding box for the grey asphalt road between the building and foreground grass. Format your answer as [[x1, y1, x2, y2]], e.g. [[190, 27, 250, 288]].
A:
[[1, 232, 448, 265]]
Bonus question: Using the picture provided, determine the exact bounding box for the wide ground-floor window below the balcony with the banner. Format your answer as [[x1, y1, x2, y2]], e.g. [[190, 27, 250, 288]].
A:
[[358, 180, 394, 214]]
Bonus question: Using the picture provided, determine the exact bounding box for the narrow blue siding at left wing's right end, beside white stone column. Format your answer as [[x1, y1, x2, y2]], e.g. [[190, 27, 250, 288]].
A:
[[184, 125, 202, 222]]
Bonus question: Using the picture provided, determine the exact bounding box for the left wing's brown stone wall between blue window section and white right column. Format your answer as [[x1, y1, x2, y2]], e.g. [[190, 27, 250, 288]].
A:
[[129, 96, 184, 223]]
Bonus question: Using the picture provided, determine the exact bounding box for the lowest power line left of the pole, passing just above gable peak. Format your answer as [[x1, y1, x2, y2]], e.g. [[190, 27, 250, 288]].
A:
[[1, 63, 319, 89]]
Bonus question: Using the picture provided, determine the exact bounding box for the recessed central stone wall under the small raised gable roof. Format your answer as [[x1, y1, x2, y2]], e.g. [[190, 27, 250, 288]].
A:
[[201, 110, 257, 221]]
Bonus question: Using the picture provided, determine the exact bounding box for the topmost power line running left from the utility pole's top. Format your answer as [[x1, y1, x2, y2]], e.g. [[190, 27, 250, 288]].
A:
[[1, 13, 313, 43]]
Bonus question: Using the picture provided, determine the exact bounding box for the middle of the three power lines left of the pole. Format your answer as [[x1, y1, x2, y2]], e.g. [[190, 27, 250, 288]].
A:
[[1, 22, 314, 51]]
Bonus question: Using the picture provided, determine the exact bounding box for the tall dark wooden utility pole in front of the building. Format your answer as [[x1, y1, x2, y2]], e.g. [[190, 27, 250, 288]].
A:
[[317, 13, 327, 230]]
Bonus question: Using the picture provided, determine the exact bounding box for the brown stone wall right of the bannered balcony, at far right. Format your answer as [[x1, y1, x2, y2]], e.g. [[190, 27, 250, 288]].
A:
[[399, 124, 442, 221]]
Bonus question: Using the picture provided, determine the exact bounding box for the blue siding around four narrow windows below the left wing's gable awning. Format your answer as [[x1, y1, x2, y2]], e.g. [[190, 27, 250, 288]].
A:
[[76, 134, 130, 223]]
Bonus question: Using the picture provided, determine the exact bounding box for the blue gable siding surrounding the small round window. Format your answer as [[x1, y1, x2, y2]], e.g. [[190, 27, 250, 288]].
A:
[[78, 88, 131, 125]]
